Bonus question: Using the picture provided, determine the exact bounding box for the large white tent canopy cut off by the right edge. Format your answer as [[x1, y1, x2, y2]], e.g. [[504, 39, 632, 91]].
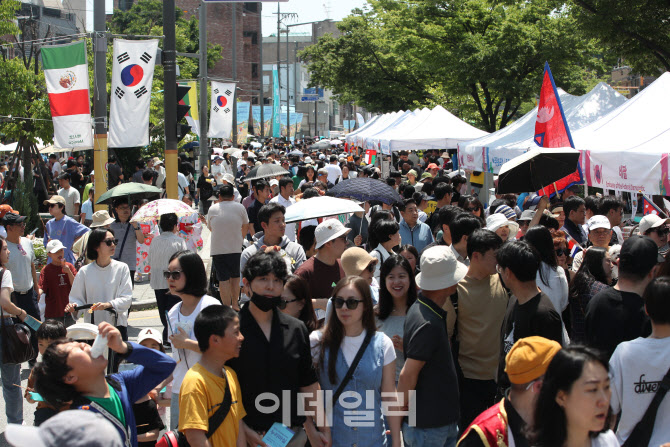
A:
[[572, 72, 670, 195]]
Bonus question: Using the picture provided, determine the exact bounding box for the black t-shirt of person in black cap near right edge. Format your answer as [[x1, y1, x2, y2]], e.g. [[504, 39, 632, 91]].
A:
[[584, 287, 651, 358]]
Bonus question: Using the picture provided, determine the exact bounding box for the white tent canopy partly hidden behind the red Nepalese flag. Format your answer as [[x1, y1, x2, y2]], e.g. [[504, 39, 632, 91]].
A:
[[458, 82, 626, 174]]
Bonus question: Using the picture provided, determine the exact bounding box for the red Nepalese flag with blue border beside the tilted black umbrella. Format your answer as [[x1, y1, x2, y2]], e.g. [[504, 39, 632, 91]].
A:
[[534, 62, 584, 196]]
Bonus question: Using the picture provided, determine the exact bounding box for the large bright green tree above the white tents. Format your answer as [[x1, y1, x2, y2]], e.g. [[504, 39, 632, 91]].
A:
[[302, 0, 616, 132]]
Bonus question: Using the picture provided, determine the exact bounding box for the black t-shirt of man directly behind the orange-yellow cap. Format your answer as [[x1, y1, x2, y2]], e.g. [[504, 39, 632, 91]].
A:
[[498, 292, 563, 388]]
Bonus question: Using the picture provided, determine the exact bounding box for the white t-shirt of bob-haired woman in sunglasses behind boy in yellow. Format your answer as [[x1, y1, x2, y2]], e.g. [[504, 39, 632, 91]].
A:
[[168, 295, 221, 394]]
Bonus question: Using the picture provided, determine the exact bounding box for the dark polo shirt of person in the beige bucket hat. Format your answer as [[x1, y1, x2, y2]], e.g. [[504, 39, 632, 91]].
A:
[[403, 294, 460, 428]]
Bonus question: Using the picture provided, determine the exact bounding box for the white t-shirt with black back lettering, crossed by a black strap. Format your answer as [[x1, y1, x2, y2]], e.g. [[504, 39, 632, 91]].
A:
[[610, 337, 670, 446]]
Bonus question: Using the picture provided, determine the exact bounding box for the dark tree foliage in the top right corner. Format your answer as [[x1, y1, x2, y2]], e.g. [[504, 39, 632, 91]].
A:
[[572, 0, 670, 74]]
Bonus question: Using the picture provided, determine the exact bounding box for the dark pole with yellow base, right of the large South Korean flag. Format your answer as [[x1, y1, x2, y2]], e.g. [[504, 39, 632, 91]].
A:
[[163, 0, 179, 199]]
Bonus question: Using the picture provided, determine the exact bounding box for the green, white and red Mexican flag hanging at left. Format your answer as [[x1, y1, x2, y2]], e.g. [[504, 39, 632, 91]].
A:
[[42, 40, 93, 149]]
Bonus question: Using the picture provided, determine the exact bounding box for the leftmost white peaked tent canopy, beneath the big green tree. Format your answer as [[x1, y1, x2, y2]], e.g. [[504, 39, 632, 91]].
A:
[[381, 106, 487, 154]]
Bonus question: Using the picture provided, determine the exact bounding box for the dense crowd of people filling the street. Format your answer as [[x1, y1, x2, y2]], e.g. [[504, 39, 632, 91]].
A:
[[0, 146, 670, 447]]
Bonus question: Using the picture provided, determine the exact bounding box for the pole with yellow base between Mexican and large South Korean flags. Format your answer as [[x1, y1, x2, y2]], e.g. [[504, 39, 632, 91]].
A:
[[93, 0, 107, 211]]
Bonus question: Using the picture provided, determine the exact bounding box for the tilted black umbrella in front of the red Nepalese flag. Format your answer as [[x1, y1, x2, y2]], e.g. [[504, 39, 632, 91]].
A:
[[498, 148, 579, 194]]
